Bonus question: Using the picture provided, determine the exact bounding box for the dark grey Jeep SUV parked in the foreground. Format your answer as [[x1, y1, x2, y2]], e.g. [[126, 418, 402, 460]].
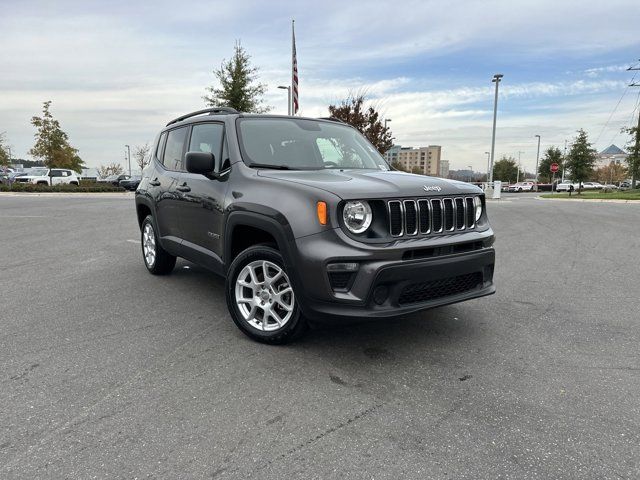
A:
[[135, 107, 495, 343]]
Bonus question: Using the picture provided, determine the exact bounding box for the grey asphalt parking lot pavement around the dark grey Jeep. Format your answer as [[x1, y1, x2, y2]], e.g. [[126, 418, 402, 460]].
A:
[[0, 196, 640, 479]]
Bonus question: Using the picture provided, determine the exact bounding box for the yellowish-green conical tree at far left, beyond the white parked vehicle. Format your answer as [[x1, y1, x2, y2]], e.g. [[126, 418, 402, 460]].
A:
[[29, 100, 84, 173]]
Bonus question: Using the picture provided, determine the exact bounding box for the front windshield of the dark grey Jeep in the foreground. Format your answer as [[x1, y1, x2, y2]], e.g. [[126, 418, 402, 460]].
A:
[[238, 118, 389, 170]]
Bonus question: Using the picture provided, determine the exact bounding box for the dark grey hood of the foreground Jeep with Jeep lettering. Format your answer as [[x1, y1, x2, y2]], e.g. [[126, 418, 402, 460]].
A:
[[258, 169, 482, 200]]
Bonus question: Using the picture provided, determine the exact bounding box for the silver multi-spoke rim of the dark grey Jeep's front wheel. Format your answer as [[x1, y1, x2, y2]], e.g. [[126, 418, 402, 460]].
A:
[[235, 260, 295, 332]]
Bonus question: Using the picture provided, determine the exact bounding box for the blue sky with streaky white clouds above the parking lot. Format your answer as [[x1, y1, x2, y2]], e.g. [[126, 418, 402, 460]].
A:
[[0, 0, 640, 172]]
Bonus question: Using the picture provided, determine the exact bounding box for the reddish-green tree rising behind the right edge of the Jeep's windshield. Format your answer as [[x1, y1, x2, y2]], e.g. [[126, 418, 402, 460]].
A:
[[329, 94, 393, 154]]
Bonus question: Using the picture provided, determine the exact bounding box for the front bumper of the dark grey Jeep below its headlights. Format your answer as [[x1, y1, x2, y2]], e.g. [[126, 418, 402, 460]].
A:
[[290, 228, 495, 322]]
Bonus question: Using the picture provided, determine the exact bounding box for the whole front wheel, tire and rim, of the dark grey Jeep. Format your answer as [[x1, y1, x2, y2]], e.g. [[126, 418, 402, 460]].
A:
[[225, 245, 307, 344]]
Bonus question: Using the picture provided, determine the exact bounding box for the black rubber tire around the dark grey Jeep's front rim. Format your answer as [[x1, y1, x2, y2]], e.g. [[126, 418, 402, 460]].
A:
[[225, 245, 308, 345]]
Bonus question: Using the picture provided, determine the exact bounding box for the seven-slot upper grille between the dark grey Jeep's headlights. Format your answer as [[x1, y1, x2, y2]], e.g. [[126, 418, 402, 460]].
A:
[[387, 197, 479, 237]]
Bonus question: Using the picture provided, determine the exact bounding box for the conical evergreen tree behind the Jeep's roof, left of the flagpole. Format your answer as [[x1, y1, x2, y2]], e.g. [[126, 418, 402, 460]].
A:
[[202, 41, 271, 113]]
